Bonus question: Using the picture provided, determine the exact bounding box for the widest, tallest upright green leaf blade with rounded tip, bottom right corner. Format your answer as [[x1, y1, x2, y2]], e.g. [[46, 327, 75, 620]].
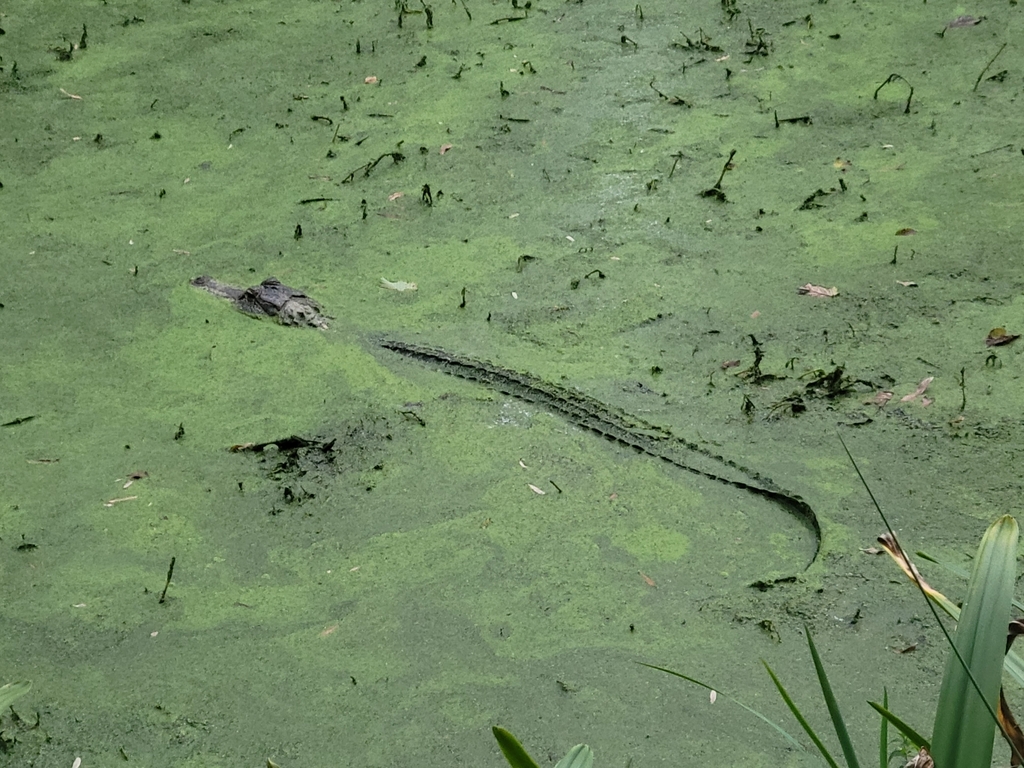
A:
[[932, 515, 1018, 768]]
